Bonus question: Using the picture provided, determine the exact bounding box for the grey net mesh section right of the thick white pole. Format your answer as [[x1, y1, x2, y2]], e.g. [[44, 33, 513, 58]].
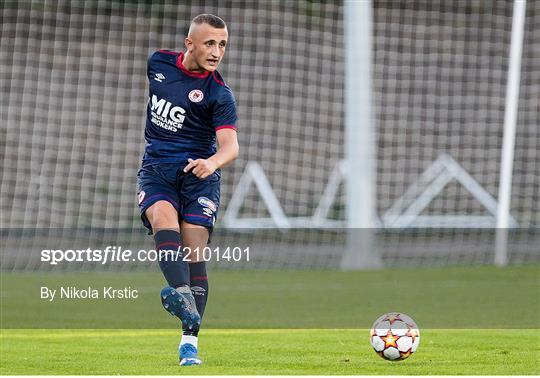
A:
[[374, 1, 540, 227]]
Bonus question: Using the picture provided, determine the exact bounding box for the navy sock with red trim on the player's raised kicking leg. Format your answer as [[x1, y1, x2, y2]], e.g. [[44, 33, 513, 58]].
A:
[[154, 230, 189, 289]]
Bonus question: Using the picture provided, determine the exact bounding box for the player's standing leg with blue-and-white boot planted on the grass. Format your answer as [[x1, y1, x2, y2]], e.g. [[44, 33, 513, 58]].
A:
[[178, 221, 209, 365]]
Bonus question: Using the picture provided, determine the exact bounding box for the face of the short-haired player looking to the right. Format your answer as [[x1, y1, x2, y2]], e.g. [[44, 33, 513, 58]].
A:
[[186, 24, 229, 72]]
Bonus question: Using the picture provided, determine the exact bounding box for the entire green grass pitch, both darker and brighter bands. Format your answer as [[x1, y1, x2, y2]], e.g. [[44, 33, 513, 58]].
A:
[[0, 266, 540, 375]]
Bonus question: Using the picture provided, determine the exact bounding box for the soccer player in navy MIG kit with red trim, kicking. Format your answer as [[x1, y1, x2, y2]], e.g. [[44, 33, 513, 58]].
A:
[[137, 14, 238, 365]]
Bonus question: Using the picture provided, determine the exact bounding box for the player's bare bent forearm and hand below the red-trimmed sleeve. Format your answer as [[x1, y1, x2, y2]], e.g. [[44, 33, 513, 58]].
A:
[[184, 129, 239, 179]]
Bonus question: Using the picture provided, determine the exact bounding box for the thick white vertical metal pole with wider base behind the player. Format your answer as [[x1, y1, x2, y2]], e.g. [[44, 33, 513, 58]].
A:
[[341, 0, 381, 270]]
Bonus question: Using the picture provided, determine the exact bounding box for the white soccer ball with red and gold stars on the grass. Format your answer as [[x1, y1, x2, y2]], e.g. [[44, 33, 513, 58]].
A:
[[369, 312, 420, 361]]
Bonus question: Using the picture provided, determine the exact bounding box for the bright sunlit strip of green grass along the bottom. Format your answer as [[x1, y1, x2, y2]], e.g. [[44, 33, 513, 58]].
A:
[[0, 329, 540, 375]]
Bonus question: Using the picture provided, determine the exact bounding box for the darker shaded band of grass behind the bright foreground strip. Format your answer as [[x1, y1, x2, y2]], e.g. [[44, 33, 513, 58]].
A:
[[0, 266, 540, 329]]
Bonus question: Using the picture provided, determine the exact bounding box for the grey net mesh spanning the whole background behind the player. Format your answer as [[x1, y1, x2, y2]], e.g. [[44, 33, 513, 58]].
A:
[[0, 1, 540, 267]]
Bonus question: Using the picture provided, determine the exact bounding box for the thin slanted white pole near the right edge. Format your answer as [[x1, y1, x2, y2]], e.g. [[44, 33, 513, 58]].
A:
[[495, 0, 526, 266]]
